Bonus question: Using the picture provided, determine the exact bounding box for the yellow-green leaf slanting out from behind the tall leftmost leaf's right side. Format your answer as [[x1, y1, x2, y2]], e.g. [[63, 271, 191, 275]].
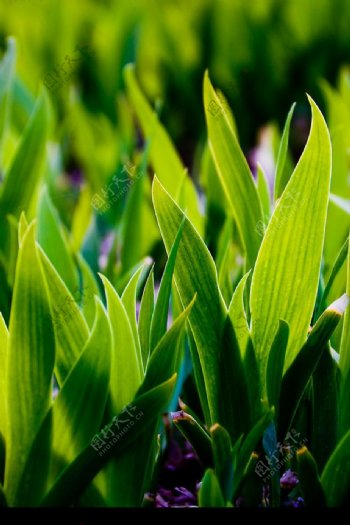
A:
[[39, 249, 89, 385]]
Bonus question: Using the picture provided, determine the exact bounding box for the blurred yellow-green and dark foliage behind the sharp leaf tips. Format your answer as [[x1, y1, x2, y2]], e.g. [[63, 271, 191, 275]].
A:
[[0, 0, 350, 289]]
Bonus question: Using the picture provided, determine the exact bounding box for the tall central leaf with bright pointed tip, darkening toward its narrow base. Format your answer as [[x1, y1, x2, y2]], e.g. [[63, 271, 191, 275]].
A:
[[153, 178, 226, 423]]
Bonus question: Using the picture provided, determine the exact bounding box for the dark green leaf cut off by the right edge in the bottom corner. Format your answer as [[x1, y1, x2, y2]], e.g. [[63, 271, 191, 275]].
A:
[[321, 430, 350, 507]]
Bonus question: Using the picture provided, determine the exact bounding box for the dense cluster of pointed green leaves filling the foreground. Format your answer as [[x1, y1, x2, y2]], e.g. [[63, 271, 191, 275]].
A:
[[0, 0, 350, 507]]
